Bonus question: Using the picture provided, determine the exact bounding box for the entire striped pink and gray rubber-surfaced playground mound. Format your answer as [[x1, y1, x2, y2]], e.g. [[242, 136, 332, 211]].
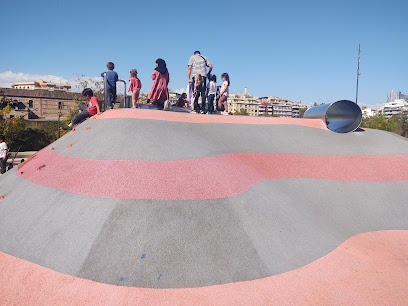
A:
[[0, 109, 408, 304]]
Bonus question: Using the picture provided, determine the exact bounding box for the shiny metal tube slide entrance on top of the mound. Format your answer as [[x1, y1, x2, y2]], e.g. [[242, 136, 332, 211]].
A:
[[303, 100, 363, 133]]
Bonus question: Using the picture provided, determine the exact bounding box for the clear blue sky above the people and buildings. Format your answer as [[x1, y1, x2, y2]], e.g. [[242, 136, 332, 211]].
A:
[[0, 0, 408, 106]]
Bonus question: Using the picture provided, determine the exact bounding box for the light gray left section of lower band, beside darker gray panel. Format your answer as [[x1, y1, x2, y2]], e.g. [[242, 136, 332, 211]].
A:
[[0, 168, 116, 275]]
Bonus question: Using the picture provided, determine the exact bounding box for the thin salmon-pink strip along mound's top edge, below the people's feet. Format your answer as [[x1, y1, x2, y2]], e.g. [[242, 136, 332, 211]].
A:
[[92, 109, 327, 130]]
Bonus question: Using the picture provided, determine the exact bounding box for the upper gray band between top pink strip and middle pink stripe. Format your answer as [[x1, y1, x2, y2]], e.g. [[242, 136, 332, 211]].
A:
[[50, 119, 408, 160]]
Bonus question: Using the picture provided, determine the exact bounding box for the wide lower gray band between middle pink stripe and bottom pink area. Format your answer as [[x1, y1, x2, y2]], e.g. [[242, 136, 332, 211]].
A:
[[0, 173, 408, 288]]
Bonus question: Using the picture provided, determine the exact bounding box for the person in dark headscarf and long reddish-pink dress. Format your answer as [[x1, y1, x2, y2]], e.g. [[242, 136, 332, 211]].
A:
[[148, 58, 170, 109]]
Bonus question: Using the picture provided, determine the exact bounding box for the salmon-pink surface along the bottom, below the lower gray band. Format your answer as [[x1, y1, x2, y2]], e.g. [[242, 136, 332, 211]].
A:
[[0, 231, 408, 305]]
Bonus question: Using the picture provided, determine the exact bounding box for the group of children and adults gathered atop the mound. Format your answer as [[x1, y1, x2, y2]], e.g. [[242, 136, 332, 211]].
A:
[[64, 51, 230, 129]]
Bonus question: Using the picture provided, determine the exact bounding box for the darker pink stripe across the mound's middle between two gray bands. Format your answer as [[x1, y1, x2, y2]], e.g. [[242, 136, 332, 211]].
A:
[[17, 149, 408, 200]]
